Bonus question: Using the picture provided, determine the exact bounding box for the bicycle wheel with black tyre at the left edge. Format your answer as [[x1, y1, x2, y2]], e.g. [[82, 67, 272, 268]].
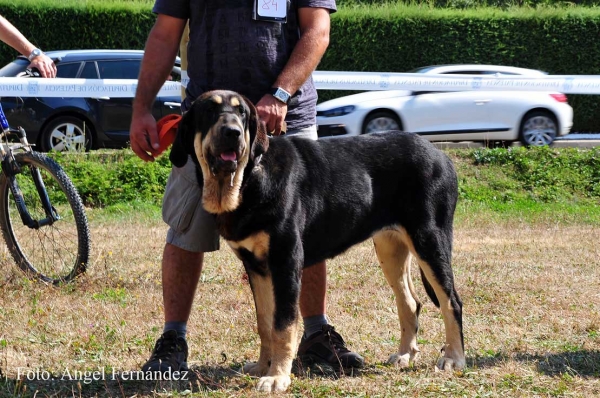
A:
[[0, 152, 90, 284]]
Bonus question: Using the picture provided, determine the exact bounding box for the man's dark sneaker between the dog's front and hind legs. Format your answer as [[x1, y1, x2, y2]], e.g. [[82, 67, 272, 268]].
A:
[[298, 325, 365, 370]]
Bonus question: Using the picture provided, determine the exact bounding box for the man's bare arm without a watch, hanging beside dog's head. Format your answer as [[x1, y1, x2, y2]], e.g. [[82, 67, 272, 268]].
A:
[[129, 14, 187, 162]]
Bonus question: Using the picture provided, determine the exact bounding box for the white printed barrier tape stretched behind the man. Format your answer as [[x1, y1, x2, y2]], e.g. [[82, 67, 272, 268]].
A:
[[0, 71, 600, 98]]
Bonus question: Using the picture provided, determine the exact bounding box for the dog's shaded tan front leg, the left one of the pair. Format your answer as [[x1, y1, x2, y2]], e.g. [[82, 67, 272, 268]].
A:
[[243, 273, 275, 377]]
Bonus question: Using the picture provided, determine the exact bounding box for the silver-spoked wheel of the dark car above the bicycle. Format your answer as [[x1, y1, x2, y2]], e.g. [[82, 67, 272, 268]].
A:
[[41, 116, 92, 152]]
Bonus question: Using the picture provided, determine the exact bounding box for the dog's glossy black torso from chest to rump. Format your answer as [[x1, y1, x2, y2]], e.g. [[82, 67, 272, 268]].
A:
[[219, 131, 457, 265]]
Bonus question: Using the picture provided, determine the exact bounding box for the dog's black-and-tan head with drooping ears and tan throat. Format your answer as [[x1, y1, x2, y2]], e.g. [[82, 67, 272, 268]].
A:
[[170, 90, 269, 213]]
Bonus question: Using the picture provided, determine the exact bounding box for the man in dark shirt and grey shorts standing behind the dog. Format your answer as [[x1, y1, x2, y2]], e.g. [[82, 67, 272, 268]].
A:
[[130, 0, 364, 371]]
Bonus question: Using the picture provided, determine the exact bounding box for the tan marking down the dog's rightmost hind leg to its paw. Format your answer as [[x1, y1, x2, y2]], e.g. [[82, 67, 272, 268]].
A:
[[417, 258, 466, 370]]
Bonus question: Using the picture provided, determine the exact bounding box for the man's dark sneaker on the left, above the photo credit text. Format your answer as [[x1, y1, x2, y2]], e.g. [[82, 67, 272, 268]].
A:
[[142, 330, 188, 373]]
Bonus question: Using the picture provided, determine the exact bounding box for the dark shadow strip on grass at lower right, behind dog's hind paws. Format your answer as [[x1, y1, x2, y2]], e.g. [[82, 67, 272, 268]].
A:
[[467, 350, 600, 378]]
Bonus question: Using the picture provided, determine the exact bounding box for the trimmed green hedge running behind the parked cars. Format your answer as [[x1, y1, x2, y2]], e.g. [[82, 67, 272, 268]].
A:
[[0, 0, 600, 131]]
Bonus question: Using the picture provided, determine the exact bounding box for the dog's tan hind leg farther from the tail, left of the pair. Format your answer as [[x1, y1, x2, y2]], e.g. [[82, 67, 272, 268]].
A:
[[373, 230, 421, 367]]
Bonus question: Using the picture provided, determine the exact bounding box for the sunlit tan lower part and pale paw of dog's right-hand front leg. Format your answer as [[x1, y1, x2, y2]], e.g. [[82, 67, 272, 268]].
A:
[[256, 319, 298, 391]]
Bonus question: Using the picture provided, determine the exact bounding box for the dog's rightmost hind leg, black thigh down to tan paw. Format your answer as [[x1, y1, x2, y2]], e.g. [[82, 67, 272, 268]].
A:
[[412, 227, 466, 370]]
